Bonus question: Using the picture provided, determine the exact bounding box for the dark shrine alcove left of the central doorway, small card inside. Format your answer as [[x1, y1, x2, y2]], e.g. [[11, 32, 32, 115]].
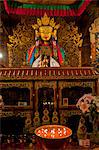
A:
[[0, 87, 30, 106]]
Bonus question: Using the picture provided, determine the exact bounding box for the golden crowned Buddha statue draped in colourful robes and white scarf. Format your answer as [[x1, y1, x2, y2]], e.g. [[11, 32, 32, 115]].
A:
[[27, 13, 67, 67]]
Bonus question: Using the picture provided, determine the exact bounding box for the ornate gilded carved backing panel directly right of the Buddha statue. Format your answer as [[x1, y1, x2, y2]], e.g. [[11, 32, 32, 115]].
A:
[[58, 18, 83, 67]]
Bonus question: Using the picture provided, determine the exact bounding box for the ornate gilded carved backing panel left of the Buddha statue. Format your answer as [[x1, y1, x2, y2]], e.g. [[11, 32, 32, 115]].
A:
[[7, 18, 34, 67]]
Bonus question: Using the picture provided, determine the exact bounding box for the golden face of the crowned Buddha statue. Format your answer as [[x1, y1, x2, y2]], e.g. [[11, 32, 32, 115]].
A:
[[39, 26, 53, 41]]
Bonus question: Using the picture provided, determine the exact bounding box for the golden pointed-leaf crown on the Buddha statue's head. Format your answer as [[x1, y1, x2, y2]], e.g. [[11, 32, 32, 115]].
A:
[[32, 13, 60, 30]]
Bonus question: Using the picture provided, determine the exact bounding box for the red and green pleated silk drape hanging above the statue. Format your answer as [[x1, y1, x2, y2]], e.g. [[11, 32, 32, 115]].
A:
[[4, 0, 92, 17]]
